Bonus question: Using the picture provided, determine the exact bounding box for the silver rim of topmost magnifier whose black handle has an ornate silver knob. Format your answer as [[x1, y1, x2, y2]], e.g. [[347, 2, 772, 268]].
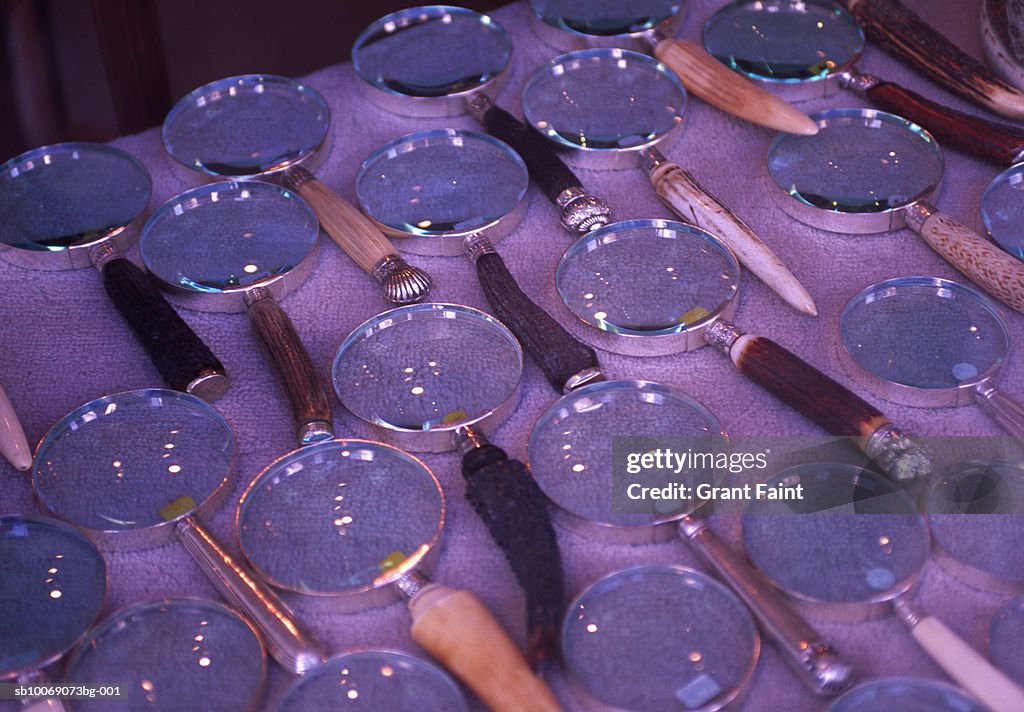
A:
[[352, 5, 512, 118]]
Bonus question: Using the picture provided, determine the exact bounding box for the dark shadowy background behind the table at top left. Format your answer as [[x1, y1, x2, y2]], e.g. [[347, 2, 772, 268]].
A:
[[0, 0, 503, 163]]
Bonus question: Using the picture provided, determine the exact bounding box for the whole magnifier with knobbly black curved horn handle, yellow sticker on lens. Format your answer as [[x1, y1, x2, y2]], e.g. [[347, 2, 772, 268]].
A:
[[332, 304, 565, 664]]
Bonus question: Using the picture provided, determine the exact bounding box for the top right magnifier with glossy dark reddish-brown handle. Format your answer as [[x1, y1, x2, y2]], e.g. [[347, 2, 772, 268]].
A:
[[703, 0, 1024, 165]]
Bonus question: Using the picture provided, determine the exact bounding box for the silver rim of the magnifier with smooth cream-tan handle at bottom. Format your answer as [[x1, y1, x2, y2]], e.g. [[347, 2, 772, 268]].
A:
[[234, 438, 447, 614]]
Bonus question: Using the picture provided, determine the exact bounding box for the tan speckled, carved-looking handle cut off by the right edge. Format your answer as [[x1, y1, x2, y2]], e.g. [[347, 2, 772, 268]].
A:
[[909, 212, 1024, 311]]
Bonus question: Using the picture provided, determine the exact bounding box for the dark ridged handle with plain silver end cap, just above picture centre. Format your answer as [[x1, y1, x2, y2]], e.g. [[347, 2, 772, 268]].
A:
[[476, 252, 600, 393]]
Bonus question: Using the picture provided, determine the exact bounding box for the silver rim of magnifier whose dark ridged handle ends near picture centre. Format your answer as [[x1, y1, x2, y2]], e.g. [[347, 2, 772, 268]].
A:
[[355, 129, 529, 257]]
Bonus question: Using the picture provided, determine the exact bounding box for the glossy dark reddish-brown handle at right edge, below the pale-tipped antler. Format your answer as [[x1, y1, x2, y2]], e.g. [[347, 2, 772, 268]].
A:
[[865, 82, 1024, 166]]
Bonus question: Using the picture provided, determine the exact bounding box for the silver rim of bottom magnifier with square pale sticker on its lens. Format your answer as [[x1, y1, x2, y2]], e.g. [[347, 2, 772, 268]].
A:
[[560, 564, 761, 712]]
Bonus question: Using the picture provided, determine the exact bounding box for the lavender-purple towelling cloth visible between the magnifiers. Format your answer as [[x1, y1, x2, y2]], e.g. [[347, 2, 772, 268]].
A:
[[0, 0, 1024, 712]]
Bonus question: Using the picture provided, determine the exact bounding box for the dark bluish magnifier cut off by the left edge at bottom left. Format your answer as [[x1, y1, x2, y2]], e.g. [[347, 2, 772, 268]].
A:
[[0, 514, 106, 710]]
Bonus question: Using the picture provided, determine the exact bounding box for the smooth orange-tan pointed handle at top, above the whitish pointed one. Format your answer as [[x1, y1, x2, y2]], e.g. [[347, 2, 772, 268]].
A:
[[654, 40, 818, 136]]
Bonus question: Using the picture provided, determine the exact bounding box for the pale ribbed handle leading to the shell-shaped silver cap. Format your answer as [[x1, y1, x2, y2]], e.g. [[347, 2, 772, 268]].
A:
[[288, 169, 398, 277]]
